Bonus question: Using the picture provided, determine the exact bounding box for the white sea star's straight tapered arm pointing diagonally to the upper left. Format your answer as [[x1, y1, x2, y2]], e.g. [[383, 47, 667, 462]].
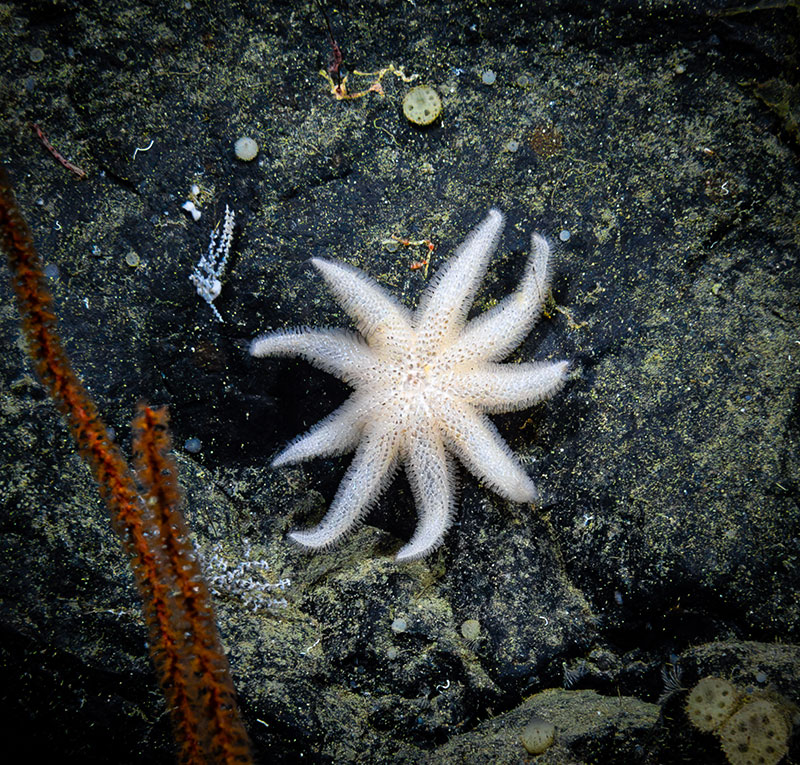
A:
[[311, 258, 413, 354]]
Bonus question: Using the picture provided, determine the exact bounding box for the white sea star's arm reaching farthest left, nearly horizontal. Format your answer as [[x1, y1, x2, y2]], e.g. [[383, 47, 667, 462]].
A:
[[250, 327, 375, 383]]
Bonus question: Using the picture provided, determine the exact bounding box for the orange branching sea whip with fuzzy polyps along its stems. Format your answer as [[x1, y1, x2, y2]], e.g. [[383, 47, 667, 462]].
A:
[[0, 165, 253, 765]]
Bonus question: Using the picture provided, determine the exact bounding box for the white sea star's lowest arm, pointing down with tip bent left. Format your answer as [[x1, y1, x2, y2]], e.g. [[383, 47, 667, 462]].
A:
[[396, 429, 456, 563]]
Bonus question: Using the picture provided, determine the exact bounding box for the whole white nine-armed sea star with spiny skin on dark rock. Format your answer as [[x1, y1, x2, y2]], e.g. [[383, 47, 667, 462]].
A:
[[250, 209, 569, 561]]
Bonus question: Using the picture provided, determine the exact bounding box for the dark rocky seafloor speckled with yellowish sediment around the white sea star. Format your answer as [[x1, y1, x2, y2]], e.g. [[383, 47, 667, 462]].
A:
[[0, 0, 800, 765]]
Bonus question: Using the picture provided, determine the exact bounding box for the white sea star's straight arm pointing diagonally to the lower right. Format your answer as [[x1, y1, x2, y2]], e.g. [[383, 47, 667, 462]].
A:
[[438, 398, 539, 502]]
